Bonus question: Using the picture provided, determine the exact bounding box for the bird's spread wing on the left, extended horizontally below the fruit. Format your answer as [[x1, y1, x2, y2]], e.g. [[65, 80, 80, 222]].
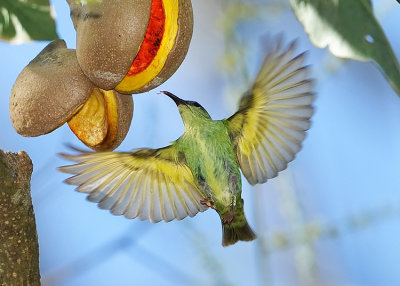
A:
[[59, 146, 207, 222]]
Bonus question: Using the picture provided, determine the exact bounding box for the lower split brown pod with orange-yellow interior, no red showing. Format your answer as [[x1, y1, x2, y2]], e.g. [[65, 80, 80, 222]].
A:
[[9, 40, 133, 150]]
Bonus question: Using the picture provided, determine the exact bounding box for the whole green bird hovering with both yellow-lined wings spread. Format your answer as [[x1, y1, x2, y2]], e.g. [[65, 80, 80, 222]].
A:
[[60, 41, 314, 246]]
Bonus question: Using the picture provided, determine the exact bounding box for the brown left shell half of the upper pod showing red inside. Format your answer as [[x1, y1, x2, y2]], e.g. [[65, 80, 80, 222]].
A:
[[75, 0, 151, 90]]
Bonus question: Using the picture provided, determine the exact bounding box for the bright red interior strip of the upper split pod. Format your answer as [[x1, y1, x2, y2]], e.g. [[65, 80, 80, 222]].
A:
[[127, 0, 165, 76]]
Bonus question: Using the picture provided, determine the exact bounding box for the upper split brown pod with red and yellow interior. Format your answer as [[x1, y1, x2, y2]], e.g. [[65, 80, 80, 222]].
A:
[[73, 0, 193, 94]]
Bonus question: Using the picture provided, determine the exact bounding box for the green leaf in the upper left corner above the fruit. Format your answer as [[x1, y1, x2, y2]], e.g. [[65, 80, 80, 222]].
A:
[[0, 0, 58, 43]]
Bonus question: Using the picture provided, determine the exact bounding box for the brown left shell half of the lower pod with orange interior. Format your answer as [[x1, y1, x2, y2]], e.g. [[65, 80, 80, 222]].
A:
[[9, 40, 94, 137]]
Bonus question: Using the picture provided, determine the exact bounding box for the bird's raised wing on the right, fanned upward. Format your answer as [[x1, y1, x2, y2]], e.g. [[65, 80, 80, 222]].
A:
[[225, 39, 314, 185]]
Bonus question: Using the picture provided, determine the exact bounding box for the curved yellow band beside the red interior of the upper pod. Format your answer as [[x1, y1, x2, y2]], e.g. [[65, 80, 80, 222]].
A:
[[115, 0, 179, 93]]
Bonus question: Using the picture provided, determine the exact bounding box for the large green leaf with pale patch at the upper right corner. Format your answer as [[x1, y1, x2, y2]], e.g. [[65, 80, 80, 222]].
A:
[[290, 0, 400, 96]]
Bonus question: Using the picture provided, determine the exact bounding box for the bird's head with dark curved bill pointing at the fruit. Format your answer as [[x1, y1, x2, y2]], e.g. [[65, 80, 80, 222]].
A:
[[161, 91, 211, 124]]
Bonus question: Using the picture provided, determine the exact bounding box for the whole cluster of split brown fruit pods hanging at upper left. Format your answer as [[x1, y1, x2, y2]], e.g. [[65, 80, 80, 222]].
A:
[[10, 0, 193, 150]]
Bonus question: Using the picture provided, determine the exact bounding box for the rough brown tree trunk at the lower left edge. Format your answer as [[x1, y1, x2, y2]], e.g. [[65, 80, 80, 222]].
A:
[[0, 150, 40, 286]]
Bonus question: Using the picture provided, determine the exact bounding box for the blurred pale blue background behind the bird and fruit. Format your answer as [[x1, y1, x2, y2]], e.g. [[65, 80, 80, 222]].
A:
[[0, 0, 400, 286]]
